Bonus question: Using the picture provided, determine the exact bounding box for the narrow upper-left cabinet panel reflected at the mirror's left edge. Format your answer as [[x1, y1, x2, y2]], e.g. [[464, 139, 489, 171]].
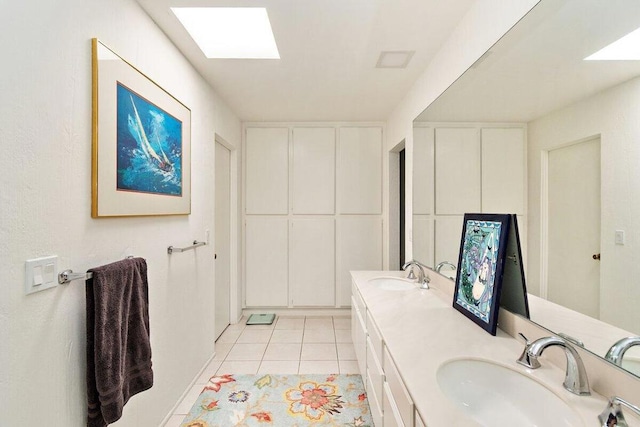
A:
[[413, 127, 434, 215]]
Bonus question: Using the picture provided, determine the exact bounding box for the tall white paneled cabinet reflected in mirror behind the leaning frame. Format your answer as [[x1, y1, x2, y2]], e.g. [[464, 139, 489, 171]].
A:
[[412, 123, 527, 265]]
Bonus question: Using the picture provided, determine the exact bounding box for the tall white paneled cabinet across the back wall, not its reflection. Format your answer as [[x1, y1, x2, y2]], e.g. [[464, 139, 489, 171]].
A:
[[244, 124, 383, 308]]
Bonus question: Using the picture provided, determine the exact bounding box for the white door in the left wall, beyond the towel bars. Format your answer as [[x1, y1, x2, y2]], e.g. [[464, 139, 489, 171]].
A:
[[214, 142, 231, 339]]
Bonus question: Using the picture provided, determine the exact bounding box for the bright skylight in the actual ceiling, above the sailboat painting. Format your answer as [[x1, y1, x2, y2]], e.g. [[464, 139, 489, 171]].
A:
[[171, 7, 280, 59]]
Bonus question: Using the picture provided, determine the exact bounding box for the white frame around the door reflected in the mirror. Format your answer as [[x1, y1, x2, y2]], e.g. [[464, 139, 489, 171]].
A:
[[540, 133, 602, 300]]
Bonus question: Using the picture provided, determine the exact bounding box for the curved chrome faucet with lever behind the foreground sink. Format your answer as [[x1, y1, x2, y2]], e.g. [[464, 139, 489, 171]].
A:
[[517, 334, 591, 396]]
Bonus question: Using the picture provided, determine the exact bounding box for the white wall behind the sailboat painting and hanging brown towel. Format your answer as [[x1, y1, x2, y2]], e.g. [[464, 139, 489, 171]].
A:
[[0, 0, 241, 427]]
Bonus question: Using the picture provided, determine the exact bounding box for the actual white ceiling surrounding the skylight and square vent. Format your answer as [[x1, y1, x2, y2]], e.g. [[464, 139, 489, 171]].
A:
[[137, 0, 476, 121]]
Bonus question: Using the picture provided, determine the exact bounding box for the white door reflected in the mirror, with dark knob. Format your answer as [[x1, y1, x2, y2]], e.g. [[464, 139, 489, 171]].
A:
[[547, 138, 600, 319]]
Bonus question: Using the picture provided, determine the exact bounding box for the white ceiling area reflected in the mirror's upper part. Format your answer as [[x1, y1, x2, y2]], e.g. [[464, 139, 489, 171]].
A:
[[417, 0, 640, 123]]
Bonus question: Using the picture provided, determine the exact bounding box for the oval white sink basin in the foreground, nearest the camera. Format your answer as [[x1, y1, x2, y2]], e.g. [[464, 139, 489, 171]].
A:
[[437, 359, 583, 426]]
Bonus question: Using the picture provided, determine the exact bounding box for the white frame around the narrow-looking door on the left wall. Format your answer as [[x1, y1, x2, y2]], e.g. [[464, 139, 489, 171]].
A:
[[218, 133, 242, 324]]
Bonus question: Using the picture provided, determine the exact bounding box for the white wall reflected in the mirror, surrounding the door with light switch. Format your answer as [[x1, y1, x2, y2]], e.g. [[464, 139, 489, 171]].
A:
[[527, 78, 640, 333]]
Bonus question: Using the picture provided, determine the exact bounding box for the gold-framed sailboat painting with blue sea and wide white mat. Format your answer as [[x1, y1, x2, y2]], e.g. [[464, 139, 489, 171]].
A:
[[91, 39, 191, 218]]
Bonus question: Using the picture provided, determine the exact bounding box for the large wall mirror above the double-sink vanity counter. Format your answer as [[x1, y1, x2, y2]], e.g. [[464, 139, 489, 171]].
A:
[[412, 0, 640, 376]]
